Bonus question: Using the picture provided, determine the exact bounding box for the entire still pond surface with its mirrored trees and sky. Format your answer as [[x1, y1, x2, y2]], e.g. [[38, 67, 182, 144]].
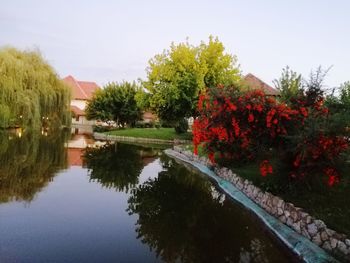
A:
[[0, 133, 290, 262]]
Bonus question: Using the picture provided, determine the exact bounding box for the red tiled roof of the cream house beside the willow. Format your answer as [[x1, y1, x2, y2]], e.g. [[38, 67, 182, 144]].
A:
[[63, 75, 100, 100]]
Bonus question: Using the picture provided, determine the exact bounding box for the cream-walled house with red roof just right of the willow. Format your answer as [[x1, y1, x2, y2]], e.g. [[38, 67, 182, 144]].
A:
[[63, 75, 100, 125]]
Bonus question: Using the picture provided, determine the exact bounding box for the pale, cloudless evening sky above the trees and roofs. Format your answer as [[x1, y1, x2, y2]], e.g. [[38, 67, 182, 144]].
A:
[[0, 0, 350, 88]]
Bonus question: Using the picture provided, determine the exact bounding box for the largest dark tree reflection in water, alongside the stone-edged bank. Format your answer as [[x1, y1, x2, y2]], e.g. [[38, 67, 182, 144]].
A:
[[128, 157, 284, 262]]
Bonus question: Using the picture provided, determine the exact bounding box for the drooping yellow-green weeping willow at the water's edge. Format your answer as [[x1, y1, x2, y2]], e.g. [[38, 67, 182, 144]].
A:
[[0, 48, 70, 128]]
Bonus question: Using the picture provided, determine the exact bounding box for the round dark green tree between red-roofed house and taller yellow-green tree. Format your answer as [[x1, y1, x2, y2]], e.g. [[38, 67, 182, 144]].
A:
[[86, 82, 141, 126]]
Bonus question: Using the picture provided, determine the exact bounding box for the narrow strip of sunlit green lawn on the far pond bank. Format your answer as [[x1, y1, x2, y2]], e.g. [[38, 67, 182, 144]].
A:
[[106, 128, 192, 140]]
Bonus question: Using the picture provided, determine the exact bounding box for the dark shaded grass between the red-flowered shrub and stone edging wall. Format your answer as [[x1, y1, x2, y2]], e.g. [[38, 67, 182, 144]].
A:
[[186, 145, 350, 236]]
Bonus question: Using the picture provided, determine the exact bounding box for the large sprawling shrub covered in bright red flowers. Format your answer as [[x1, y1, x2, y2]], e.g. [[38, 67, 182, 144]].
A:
[[193, 87, 349, 186]]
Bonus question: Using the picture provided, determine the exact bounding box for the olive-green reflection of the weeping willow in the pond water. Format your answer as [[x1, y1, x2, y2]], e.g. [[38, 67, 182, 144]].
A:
[[0, 131, 69, 202]]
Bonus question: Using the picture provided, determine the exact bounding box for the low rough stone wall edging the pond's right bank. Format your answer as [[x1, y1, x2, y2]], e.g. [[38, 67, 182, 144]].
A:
[[174, 146, 350, 261]]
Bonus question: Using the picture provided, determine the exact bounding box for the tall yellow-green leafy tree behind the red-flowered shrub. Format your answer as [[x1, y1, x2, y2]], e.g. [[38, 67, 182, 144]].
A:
[[144, 37, 240, 125]]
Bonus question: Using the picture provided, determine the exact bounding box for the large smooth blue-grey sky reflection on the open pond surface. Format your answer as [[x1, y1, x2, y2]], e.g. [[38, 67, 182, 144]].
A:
[[0, 166, 161, 262]]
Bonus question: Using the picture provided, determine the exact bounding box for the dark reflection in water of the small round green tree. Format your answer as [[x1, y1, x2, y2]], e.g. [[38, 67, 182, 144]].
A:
[[84, 143, 158, 192]]
